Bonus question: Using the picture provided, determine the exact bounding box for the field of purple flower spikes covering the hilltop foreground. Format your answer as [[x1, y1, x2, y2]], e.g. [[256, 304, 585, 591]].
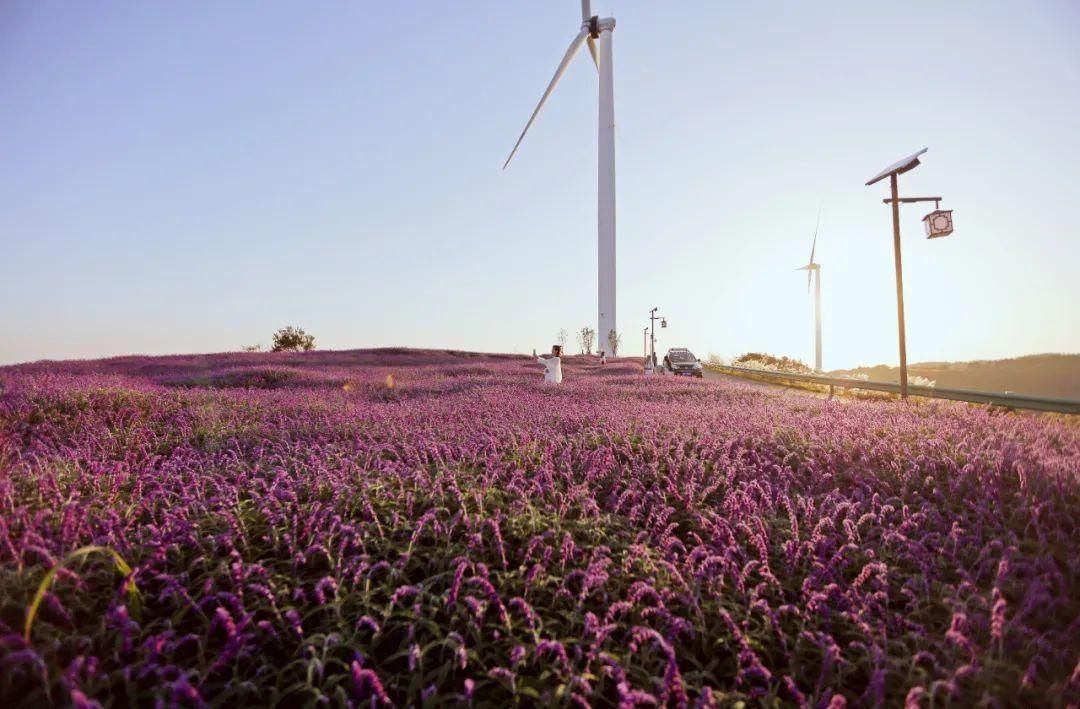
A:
[[0, 350, 1080, 708]]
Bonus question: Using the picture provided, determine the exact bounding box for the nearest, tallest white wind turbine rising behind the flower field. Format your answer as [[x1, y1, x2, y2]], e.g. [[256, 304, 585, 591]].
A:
[[502, 0, 618, 355]]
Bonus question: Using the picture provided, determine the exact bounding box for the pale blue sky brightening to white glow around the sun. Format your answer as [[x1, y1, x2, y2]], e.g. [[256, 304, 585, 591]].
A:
[[0, 0, 1080, 369]]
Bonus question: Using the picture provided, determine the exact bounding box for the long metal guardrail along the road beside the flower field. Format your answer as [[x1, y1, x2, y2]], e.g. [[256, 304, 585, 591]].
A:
[[708, 365, 1080, 414]]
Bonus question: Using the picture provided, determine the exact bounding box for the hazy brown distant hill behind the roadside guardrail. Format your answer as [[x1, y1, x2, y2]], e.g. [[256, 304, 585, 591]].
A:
[[831, 355, 1080, 399]]
